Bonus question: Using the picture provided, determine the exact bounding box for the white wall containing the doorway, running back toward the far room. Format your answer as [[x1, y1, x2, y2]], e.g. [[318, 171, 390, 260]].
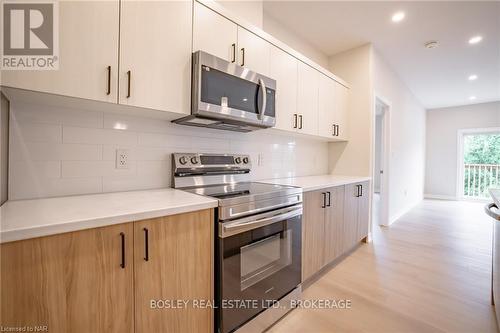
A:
[[372, 52, 426, 223]]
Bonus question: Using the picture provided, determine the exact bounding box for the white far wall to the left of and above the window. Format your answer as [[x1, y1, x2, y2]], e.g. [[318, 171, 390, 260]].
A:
[[425, 102, 500, 199]]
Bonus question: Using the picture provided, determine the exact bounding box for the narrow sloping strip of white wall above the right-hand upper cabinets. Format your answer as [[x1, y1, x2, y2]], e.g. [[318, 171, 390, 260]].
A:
[[263, 13, 330, 68]]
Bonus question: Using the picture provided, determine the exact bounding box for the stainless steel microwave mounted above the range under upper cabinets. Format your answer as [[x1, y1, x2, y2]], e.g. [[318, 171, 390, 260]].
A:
[[174, 51, 276, 132]]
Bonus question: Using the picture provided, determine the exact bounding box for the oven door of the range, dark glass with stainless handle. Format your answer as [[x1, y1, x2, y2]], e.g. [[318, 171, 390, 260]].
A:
[[218, 205, 302, 333]]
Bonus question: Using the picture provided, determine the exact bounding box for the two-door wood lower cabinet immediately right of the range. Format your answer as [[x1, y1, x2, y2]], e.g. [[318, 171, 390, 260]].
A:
[[302, 186, 344, 281]]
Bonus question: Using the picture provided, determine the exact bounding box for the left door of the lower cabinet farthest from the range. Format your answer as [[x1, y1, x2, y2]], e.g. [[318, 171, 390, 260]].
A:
[[343, 184, 359, 252]]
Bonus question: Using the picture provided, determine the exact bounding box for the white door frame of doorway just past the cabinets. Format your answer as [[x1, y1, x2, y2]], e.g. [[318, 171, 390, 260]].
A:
[[371, 92, 392, 226]]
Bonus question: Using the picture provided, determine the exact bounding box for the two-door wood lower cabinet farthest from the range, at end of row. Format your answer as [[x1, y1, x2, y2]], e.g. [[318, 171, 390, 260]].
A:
[[344, 182, 370, 251]]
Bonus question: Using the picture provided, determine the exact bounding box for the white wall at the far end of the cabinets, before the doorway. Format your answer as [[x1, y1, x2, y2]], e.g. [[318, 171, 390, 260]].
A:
[[329, 45, 373, 177]]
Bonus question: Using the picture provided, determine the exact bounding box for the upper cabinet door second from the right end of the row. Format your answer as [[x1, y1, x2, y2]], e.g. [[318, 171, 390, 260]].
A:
[[318, 74, 336, 138]]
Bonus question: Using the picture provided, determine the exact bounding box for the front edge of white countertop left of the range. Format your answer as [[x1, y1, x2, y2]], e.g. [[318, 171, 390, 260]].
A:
[[0, 200, 218, 244]]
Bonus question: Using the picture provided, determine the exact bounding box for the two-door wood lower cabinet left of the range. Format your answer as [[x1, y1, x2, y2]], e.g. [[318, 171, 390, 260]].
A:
[[0, 209, 214, 333]]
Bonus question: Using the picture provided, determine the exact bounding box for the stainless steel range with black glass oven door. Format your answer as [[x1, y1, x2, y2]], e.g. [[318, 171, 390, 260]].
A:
[[172, 153, 302, 333]]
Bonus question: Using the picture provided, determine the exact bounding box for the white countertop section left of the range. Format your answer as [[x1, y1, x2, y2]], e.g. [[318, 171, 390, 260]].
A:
[[0, 189, 218, 243]]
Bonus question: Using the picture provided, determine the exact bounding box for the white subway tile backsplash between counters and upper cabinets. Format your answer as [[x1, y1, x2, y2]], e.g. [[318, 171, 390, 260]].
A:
[[9, 102, 328, 200]]
